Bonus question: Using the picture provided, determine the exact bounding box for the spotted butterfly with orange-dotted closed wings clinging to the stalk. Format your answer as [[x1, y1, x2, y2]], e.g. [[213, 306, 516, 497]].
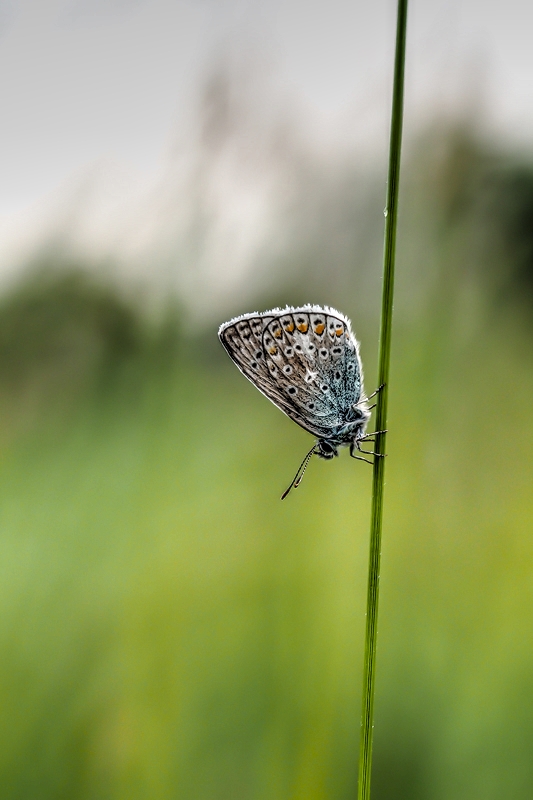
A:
[[218, 305, 383, 500]]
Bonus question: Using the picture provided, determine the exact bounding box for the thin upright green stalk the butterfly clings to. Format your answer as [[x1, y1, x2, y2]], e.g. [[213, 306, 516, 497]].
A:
[[357, 0, 407, 800]]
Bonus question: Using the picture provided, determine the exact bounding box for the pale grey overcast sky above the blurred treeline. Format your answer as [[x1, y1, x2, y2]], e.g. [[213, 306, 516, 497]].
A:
[[0, 0, 533, 276]]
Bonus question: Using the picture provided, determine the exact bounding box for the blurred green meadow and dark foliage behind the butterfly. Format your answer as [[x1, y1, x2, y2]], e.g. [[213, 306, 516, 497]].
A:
[[0, 112, 533, 800]]
